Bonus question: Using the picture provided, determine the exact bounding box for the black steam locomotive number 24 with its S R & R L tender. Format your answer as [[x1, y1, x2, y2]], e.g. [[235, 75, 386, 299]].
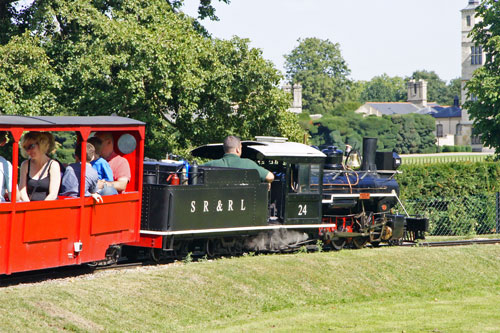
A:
[[134, 136, 426, 254]]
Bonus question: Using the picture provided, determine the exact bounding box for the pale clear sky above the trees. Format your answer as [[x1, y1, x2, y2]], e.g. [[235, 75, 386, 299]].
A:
[[182, 0, 468, 81]]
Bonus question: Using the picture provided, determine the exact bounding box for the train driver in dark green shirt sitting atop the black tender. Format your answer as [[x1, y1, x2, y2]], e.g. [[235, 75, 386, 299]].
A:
[[203, 135, 274, 184]]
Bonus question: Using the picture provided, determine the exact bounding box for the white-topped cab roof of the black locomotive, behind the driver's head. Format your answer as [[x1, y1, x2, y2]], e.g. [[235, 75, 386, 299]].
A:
[[191, 141, 326, 163]]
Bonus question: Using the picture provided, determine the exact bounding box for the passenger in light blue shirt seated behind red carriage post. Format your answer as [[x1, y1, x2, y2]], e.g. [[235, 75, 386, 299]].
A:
[[60, 142, 102, 202]]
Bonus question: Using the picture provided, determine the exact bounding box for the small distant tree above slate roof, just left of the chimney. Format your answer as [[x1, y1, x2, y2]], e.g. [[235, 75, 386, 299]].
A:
[[360, 73, 406, 103]]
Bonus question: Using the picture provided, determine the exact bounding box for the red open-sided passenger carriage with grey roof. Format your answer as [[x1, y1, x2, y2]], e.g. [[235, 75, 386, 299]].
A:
[[0, 116, 145, 274]]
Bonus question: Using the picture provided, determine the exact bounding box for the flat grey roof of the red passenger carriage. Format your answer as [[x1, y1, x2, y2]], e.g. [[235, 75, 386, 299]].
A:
[[0, 115, 145, 127]]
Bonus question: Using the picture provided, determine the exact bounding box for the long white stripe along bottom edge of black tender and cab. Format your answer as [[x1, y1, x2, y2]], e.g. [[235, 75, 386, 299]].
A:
[[141, 223, 336, 236]]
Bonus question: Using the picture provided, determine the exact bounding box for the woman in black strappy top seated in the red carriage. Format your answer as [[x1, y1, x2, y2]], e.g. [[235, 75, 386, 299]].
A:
[[19, 132, 61, 201]]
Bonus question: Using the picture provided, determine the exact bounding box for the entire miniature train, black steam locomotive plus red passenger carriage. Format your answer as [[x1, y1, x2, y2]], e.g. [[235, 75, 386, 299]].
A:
[[0, 116, 428, 274]]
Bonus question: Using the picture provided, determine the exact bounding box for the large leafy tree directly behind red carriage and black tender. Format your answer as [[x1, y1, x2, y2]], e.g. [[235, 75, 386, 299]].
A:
[[0, 0, 302, 157]]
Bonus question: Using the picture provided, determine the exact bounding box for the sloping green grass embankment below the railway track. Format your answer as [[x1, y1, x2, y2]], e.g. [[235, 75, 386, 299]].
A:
[[0, 245, 500, 332]]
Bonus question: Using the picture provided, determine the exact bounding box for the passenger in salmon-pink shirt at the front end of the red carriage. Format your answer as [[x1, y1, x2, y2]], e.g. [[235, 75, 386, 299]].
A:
[[95, 132, 131, 191]]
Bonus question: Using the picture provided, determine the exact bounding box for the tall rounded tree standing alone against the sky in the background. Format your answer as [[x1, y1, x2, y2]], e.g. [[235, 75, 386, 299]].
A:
[[285, 38, 351, 114]]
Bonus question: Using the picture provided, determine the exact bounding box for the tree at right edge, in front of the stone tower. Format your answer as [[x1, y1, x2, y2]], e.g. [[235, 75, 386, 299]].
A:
[[465, 0, 500, 154]]
